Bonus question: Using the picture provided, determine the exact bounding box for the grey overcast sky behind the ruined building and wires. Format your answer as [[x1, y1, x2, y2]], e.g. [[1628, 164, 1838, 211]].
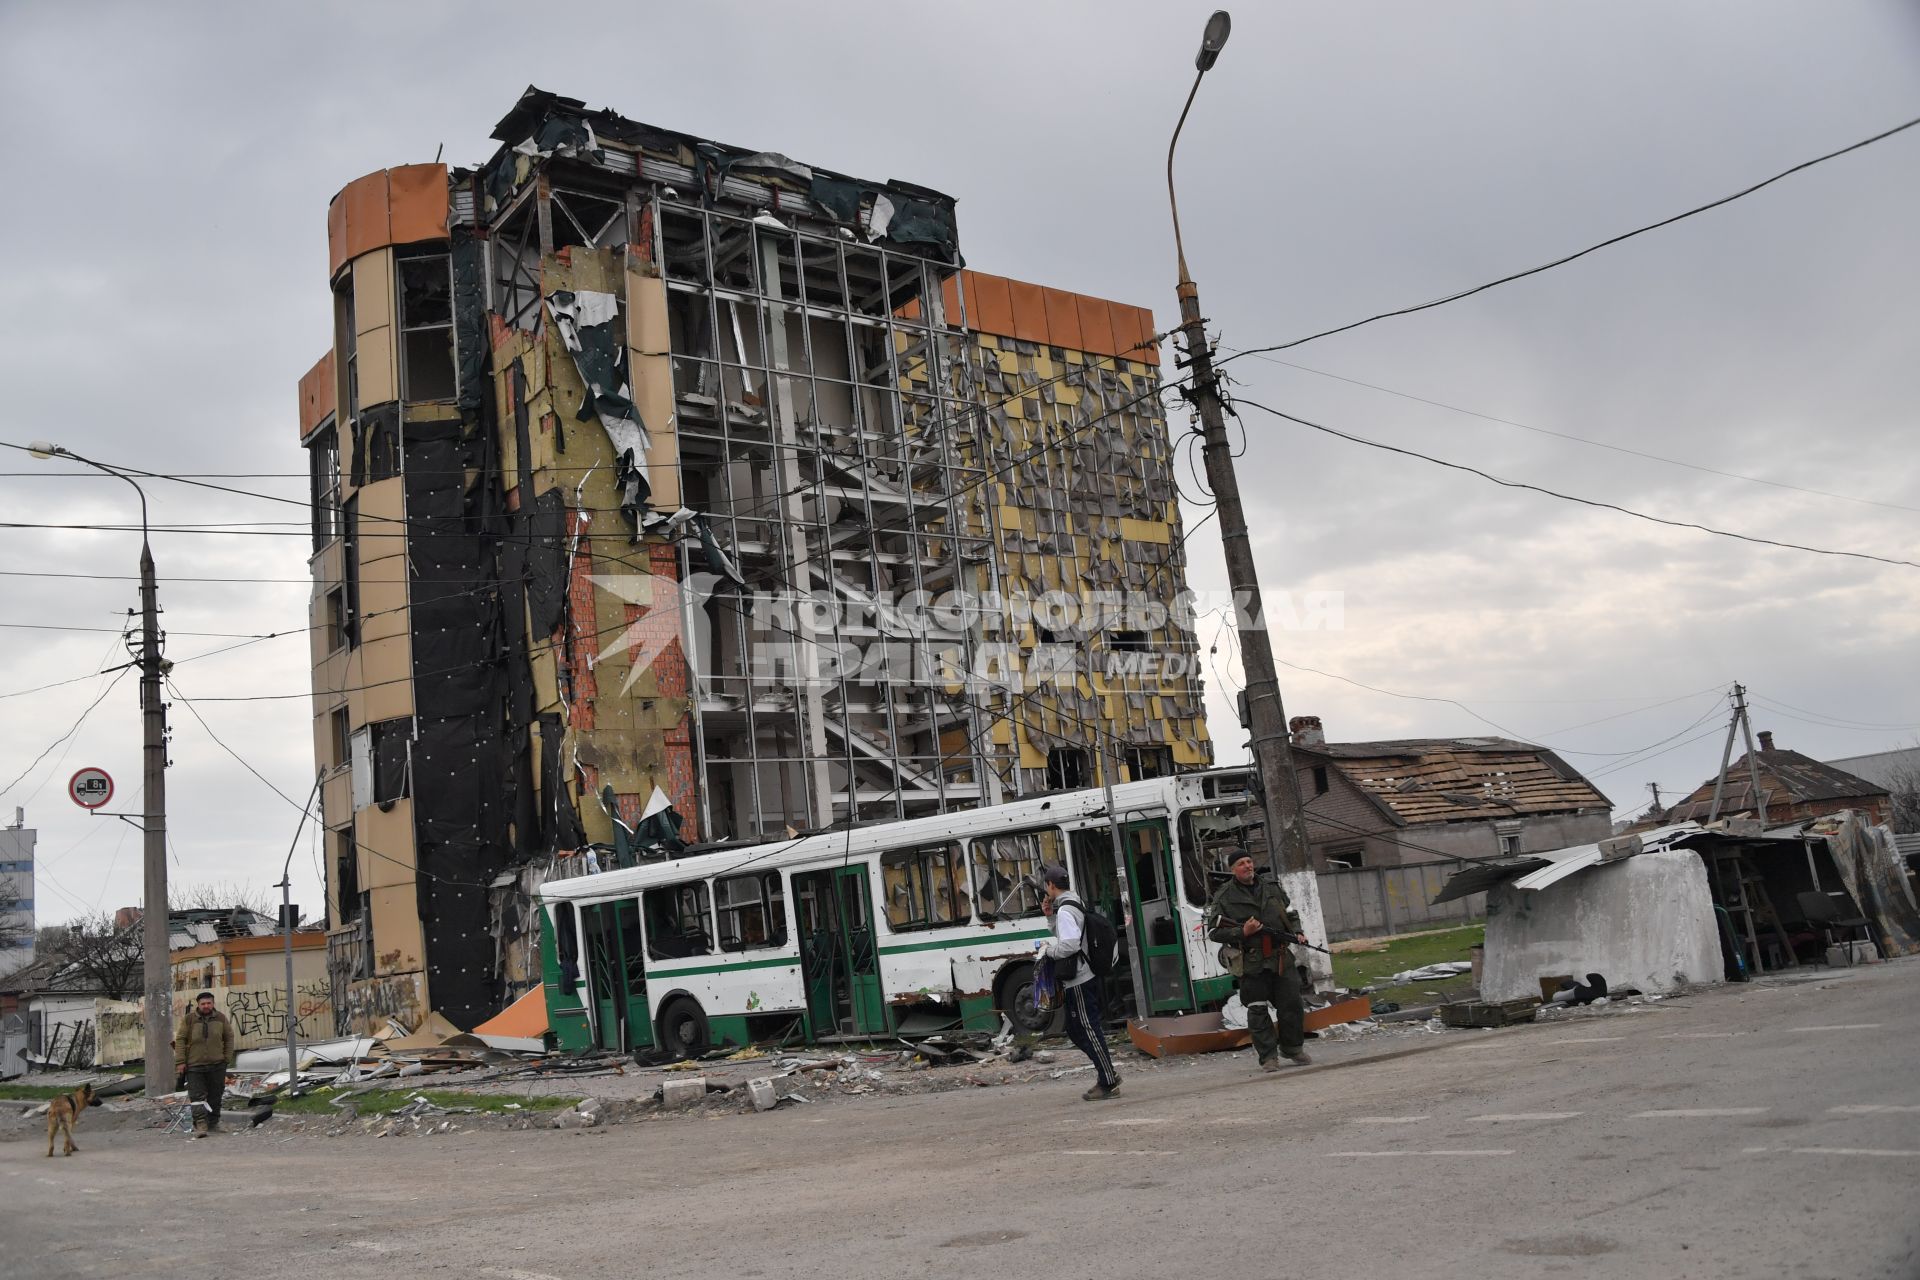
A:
[[0, 0, 1920, 923]]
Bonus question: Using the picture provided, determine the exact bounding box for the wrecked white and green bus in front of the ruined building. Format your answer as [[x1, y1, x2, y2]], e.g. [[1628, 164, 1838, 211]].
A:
[[538, 770, 1248, 1055]]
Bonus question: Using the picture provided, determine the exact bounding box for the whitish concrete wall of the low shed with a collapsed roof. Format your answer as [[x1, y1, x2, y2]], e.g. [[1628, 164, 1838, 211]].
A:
[[1480, 850, 1724, 1000]]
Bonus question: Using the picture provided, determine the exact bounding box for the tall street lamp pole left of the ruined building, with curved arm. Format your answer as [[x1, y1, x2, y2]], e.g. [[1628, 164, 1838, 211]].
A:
[[27, 439, 174, 1098]]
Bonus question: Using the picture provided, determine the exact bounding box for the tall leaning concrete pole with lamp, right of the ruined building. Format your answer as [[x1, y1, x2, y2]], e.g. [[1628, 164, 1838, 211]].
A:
[[1167, 10, 1332, 986]]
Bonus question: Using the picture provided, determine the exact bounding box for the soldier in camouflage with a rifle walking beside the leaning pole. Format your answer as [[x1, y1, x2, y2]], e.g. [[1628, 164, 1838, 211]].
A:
[[1206, 850, 1311, 1071]]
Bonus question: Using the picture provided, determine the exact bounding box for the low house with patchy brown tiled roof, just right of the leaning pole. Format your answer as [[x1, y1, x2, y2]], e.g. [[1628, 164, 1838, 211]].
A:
[[1288, 716, 1613, 871]]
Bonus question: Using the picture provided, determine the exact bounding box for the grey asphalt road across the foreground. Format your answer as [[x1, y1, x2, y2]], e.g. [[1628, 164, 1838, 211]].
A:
[[0, 961, 1920, 1280]]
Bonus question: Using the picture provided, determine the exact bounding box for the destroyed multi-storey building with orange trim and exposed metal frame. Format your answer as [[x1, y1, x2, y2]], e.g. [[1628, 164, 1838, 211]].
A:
[[300, 90, 1212, 1029]]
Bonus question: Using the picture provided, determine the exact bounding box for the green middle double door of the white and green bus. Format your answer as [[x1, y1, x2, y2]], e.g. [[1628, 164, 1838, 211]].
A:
[[793, 865, 887, 1036]]
